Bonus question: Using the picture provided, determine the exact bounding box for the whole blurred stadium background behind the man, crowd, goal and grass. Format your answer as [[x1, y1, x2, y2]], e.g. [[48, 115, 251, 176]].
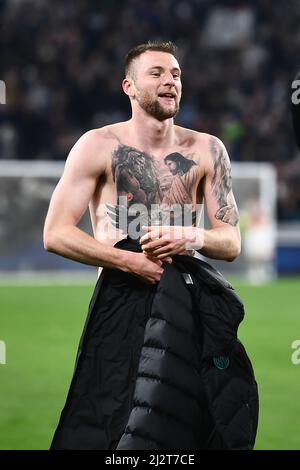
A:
[[0, 0, 300, 449]]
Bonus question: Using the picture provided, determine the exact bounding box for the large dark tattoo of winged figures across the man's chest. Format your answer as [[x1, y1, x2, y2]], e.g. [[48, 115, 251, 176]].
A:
[[107, 144, 199, 232]]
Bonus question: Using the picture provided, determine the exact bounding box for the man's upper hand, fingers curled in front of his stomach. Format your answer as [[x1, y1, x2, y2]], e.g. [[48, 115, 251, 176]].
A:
[[140, 225, 203, 260]]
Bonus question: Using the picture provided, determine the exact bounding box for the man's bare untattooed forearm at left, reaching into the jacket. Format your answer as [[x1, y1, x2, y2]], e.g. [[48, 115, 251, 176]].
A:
[[44, 225, 134, 271]]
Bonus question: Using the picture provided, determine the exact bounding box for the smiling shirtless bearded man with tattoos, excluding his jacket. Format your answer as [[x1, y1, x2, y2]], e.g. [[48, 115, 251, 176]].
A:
[[44, 42, 241, 284]]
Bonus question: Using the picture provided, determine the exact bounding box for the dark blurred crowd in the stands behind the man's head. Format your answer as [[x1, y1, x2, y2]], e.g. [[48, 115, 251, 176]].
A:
[[0, 0, 300, 220]]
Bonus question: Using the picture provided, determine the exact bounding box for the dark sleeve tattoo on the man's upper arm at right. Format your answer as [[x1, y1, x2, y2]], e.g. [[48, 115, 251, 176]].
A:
[[210, 138, 239, 226]]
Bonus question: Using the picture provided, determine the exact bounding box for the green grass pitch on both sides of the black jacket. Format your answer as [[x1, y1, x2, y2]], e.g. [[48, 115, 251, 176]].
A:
[[0, 278, 300, 449]]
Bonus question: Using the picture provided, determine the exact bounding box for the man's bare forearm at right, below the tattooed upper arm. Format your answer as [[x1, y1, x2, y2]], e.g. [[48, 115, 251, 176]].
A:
[[197, 227, 241, 261]]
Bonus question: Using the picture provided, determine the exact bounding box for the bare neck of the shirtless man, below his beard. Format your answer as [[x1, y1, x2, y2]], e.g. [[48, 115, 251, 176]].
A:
[[129, 111, 176, 151]]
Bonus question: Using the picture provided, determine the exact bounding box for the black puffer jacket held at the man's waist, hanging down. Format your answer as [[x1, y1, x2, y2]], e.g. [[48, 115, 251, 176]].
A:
[[51, 238, 258, 450]]
